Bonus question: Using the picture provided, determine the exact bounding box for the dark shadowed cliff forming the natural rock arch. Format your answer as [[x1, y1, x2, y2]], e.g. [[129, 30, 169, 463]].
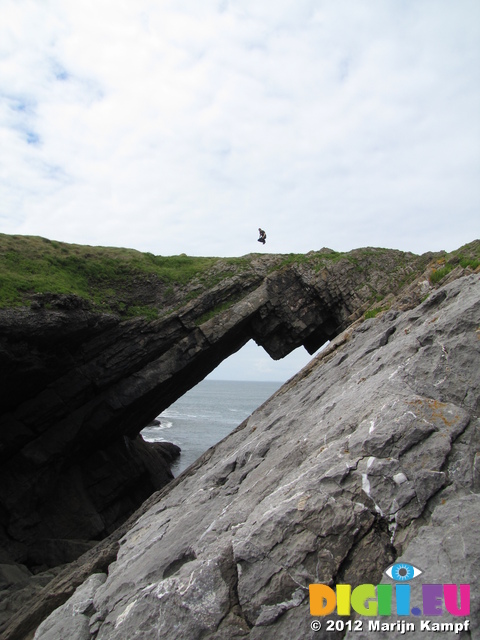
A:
[[0, 249, 438, 566]]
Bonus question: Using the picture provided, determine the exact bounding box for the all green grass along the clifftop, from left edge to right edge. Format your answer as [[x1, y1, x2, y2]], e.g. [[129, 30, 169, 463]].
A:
[[0, 234, 480, 318]]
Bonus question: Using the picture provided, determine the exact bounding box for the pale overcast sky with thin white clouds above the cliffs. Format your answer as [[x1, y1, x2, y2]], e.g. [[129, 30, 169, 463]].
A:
[[0, 0, 480, 376]]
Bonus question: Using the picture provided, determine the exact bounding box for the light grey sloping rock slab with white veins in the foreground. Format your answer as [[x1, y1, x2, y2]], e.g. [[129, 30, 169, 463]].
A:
[[5, 274, 480, 640]]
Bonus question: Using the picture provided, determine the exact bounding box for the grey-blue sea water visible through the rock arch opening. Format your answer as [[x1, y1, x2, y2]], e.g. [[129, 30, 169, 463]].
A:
[[142, 380, 282, 476]]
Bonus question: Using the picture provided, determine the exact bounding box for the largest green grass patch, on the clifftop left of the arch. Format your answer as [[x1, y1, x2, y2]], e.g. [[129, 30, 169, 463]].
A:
[[0, 234, 218, 317]]
